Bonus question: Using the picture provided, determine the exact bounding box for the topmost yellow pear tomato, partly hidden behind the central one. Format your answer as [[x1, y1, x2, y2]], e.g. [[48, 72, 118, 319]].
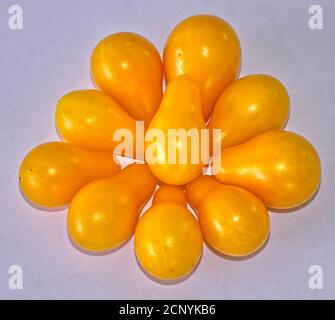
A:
[[163, 15, 241, 120]]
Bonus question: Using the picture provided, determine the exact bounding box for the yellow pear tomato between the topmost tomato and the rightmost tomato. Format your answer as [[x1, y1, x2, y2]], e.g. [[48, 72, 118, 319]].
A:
[[208, 74, 290, 148]]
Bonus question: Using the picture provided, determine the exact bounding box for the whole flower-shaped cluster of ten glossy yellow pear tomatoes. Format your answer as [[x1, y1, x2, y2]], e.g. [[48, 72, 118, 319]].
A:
[[19, 15, 321, 280]]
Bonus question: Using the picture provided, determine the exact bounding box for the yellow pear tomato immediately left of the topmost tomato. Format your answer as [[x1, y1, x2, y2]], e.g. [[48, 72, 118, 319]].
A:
[[91, 32, 163, 123]]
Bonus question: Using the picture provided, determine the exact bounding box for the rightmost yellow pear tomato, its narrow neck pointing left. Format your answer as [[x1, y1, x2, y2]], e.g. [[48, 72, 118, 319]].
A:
[[213, 131, 321, 209]]
